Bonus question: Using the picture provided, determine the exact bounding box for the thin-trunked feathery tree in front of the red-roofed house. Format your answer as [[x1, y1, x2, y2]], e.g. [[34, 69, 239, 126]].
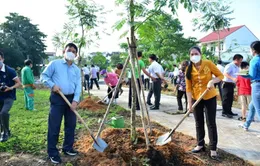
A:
[[193, 0, 233, 59]]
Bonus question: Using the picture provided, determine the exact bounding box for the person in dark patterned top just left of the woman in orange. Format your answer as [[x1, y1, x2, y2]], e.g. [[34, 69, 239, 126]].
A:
[[176, 61, 188, 113]]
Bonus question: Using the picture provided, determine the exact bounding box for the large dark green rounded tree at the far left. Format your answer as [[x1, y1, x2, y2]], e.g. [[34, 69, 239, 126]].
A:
[[0, 13, 47, 75]]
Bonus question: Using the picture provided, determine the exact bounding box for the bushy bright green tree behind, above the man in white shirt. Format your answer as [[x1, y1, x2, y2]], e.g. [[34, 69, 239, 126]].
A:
[[137, 12, 197, 64]]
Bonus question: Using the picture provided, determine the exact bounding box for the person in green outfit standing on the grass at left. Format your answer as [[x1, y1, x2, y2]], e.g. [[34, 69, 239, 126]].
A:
[[21, 59, 36, 111]]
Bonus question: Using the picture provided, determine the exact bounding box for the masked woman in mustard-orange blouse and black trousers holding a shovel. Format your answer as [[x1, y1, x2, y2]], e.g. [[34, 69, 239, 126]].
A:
[[186, 46, 224, 160]]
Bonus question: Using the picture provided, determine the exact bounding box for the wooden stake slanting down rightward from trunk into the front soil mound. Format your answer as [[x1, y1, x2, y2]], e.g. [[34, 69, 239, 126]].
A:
[[127, 38, 150, 149]]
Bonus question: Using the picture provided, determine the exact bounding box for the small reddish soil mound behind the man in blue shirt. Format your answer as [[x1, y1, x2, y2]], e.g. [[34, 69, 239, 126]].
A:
[[79, 97, 106, 111]]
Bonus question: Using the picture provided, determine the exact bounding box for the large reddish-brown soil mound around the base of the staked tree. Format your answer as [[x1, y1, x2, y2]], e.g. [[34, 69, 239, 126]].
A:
[[76, 128, 204, 166]]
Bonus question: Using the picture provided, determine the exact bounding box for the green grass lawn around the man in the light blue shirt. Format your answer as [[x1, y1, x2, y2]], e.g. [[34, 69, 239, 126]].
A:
[[0, 90, 128, 155]]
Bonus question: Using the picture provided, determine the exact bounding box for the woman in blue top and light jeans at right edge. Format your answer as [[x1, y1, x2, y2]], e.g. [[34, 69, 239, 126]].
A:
[[240, 41, 260, 132]]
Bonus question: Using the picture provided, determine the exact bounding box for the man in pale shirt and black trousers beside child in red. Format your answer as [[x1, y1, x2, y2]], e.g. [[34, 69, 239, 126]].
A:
[[222, 54, 243, 118]]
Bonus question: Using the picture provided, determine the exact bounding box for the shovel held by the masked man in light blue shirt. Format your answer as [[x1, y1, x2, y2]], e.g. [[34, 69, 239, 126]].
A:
[[58, 91, 108, 152]]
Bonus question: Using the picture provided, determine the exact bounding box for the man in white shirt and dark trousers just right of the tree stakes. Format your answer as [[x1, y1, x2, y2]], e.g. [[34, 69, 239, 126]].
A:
[[147, 54, 165, 110]]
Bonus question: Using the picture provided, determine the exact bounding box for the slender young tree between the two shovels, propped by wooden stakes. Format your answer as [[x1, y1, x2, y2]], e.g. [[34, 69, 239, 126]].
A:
[[114, 0, 197, 144]]
